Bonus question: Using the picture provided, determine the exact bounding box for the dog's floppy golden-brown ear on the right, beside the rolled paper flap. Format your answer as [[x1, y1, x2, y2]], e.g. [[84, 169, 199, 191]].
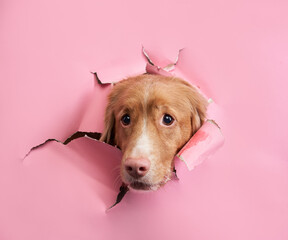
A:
[[189, 86, 208, 135]]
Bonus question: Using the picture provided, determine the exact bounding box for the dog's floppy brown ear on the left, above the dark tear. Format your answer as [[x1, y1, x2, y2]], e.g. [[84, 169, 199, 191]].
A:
[[100, 98, 115, 145]]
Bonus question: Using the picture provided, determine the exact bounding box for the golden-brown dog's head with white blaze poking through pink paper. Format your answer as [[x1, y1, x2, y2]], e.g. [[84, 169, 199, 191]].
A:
[[100, 74, 208, 191]]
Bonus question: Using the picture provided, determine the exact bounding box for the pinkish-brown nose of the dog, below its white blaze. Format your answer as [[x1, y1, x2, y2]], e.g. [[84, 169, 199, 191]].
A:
[[124, 158, 150, 178]]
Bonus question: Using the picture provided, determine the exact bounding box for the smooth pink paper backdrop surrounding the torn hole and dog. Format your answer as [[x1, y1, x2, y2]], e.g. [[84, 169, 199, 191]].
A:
[[0, 0, 288, 240]]
